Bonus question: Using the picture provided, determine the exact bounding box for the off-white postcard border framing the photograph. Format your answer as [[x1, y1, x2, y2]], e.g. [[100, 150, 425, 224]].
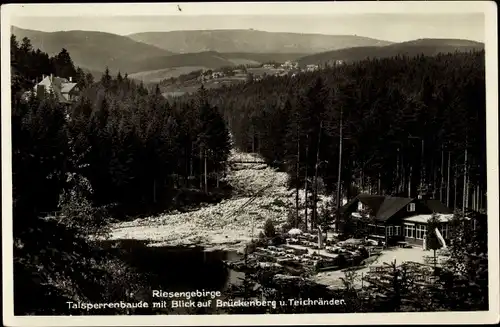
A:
[[1, 1, 500, 326]]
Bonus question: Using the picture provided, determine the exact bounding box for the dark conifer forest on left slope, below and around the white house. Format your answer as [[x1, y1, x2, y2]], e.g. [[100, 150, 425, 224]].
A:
[[11, 37, 229, 314]]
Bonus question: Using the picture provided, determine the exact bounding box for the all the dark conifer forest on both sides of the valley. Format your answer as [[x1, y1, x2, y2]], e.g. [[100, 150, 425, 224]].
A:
[[11, 36, 488, 315]]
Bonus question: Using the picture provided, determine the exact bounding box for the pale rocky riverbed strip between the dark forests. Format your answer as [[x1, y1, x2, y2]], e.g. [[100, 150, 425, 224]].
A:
[[111, 150, 324, 251]]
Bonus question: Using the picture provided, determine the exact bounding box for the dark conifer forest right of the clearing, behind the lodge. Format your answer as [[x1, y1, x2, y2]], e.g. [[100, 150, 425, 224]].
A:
[[203, 51, 486, 228]]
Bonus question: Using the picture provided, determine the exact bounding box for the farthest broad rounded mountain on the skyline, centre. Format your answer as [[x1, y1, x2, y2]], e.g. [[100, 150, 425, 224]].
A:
[[128, 29, 392, 54]]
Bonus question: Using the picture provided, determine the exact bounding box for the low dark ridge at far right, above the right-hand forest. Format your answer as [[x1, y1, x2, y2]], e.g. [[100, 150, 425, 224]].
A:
[[298, 38, 484, 65]]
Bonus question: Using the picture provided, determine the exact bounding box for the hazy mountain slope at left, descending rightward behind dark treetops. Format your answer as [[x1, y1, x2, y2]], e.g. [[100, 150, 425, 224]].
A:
[[8, 27, 304, 76]]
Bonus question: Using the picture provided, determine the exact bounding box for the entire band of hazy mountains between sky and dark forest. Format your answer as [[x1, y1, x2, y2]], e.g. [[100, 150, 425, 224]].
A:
[[12, 27, 484, 78]]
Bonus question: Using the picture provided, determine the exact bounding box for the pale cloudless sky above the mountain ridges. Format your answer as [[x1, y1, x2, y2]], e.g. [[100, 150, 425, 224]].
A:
[[11, 14, 484, 42]]
